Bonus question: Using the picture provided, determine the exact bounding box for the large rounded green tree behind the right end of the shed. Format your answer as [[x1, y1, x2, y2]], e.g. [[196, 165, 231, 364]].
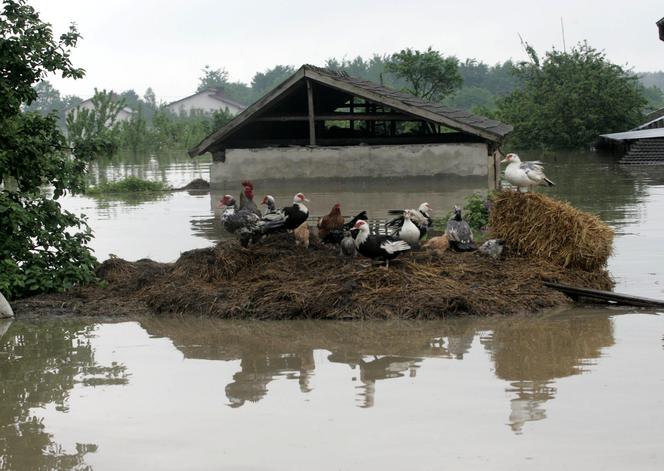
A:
[[497, 42, 646, 149]]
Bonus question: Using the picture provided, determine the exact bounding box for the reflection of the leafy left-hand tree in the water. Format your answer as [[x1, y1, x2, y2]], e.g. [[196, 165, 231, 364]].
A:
[[0, 321, 127, 470]]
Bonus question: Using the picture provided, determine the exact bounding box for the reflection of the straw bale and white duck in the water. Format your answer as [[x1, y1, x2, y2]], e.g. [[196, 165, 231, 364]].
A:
[[482, 315, 613, 433]]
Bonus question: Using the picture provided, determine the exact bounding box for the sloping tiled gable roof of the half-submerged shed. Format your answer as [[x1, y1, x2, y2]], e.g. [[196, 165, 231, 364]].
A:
[[189, 64, 513, 157]]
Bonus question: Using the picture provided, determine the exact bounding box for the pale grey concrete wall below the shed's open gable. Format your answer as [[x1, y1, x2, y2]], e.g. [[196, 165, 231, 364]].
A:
[[210, 143, 493, 185]]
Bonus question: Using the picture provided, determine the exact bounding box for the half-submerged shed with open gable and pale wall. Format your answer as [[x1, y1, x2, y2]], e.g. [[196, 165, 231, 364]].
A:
[[189, 65, 512, 188]]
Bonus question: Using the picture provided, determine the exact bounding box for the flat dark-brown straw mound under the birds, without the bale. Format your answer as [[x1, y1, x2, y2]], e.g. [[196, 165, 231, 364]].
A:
[[124, 237, 611, 319]]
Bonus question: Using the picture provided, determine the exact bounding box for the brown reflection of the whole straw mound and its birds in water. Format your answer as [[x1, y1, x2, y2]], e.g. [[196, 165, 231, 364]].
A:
[[142, 310, 614, 432]]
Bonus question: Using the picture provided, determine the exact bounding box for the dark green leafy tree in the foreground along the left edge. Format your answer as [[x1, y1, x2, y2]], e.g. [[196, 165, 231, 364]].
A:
[[0, 0, 96, 299]]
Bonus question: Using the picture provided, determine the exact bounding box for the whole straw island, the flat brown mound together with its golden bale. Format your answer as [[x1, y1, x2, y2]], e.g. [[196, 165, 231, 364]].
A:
[[14, 192, 613, 320]]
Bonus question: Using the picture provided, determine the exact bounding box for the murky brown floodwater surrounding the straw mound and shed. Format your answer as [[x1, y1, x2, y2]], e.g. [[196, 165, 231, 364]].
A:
[[0, 150, 664, 470]]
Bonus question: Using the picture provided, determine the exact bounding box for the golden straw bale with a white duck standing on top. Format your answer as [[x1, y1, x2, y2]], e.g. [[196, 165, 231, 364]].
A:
[[489, 191, 613, 272]]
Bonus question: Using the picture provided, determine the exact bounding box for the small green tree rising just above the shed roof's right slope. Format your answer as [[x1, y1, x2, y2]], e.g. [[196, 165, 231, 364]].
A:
[[385, 47, 463, 101]]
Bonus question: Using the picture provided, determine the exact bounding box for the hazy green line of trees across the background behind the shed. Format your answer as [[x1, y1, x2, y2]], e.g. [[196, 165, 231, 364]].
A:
[[25, 43, 664, 152]]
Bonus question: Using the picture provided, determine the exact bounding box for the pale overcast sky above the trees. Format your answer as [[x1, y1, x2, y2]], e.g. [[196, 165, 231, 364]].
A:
[[30, 0, 664, 101]]
